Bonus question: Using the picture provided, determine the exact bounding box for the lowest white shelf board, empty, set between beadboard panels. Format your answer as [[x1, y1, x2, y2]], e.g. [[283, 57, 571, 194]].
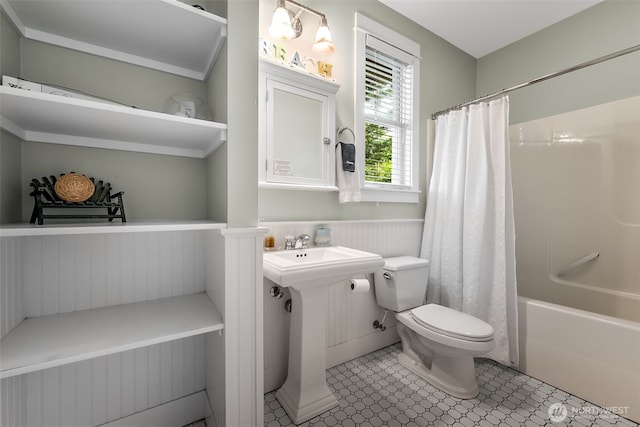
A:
[[0, 293, 224, 378]]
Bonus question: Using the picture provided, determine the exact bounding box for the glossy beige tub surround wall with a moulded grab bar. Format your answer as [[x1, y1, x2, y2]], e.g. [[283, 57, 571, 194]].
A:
[[510, 96, 640, 322]]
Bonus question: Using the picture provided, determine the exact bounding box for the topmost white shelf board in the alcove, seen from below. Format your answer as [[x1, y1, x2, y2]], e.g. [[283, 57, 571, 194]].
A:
[[0, 0, 227, 80]]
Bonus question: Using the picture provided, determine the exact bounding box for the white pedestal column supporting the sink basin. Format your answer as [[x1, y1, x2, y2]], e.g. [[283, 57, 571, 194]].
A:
[[276, 286, 338, 424]]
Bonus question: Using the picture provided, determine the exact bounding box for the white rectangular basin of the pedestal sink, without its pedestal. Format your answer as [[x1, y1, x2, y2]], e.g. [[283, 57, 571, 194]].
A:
[[262, 246, 384, 288]]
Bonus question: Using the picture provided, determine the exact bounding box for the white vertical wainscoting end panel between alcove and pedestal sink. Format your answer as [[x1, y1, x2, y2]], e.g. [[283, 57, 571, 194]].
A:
[[218, 227, 267, 427]]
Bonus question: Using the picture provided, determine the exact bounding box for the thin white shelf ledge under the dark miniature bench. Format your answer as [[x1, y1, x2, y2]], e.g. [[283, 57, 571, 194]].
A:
[[0, 221, 227, 237]]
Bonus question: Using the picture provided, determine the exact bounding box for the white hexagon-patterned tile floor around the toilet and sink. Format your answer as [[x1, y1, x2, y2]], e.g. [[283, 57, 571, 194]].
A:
[[264, 344, 638, 427]]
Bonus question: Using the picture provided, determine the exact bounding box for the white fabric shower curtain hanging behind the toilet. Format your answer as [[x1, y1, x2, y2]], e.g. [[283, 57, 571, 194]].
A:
[[421, 96, 518, 366]]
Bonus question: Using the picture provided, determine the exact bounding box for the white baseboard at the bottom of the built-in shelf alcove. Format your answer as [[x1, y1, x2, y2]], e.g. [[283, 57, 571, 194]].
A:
[[102, 391, 211, 427]]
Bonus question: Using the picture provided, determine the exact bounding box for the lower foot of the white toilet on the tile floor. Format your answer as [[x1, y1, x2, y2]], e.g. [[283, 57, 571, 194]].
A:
[[398, 353, 480, 399]]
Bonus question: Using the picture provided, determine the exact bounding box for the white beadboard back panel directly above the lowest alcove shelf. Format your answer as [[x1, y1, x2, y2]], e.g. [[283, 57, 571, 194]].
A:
[[10, 231, 206, 322]]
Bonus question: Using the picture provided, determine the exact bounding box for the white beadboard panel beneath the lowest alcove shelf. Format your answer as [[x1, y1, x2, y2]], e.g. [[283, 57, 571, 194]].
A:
[[2, 336, 205, 427]]
